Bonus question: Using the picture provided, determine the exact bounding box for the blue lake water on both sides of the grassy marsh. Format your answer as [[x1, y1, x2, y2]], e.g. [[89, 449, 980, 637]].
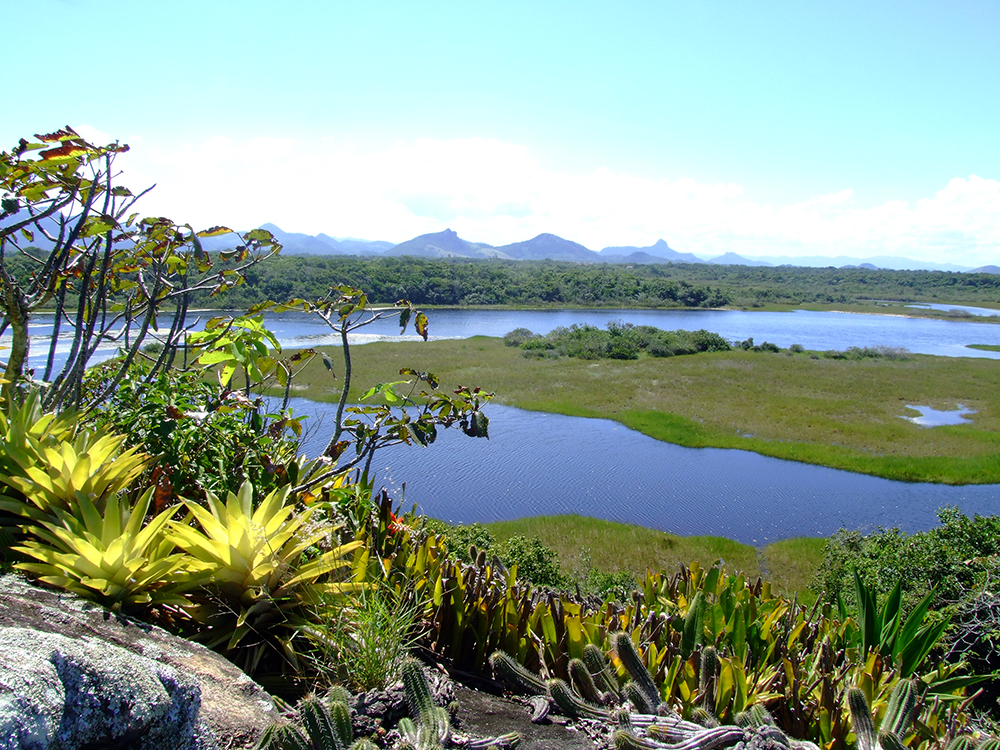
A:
[[9, 310, 1000, 544]]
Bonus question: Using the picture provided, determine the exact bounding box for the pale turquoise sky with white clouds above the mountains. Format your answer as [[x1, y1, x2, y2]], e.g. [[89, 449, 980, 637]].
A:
[[0, 0, 1000, 267]]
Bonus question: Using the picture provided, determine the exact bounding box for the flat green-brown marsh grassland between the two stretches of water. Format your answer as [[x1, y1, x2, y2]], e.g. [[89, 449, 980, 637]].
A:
[[286, 337, 1000, 484]]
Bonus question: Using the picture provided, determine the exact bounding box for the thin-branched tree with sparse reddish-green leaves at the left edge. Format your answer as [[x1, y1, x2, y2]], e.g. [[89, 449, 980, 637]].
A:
[[0, 126, 281, 409]]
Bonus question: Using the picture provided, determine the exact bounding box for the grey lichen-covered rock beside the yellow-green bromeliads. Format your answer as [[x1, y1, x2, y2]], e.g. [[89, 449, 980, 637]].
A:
[[0, 575, 278, 750]]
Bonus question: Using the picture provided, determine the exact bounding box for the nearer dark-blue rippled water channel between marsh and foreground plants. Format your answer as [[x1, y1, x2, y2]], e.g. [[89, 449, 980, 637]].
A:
[[284, 399, 1000, 545]]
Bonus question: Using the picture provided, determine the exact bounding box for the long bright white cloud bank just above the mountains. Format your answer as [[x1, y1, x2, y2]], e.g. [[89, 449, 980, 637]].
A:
[[115, 135, 1000, 265]]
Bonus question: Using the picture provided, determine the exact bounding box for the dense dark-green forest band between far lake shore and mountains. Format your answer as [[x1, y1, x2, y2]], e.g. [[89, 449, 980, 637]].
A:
[[206, 255, 1000, 307]]
